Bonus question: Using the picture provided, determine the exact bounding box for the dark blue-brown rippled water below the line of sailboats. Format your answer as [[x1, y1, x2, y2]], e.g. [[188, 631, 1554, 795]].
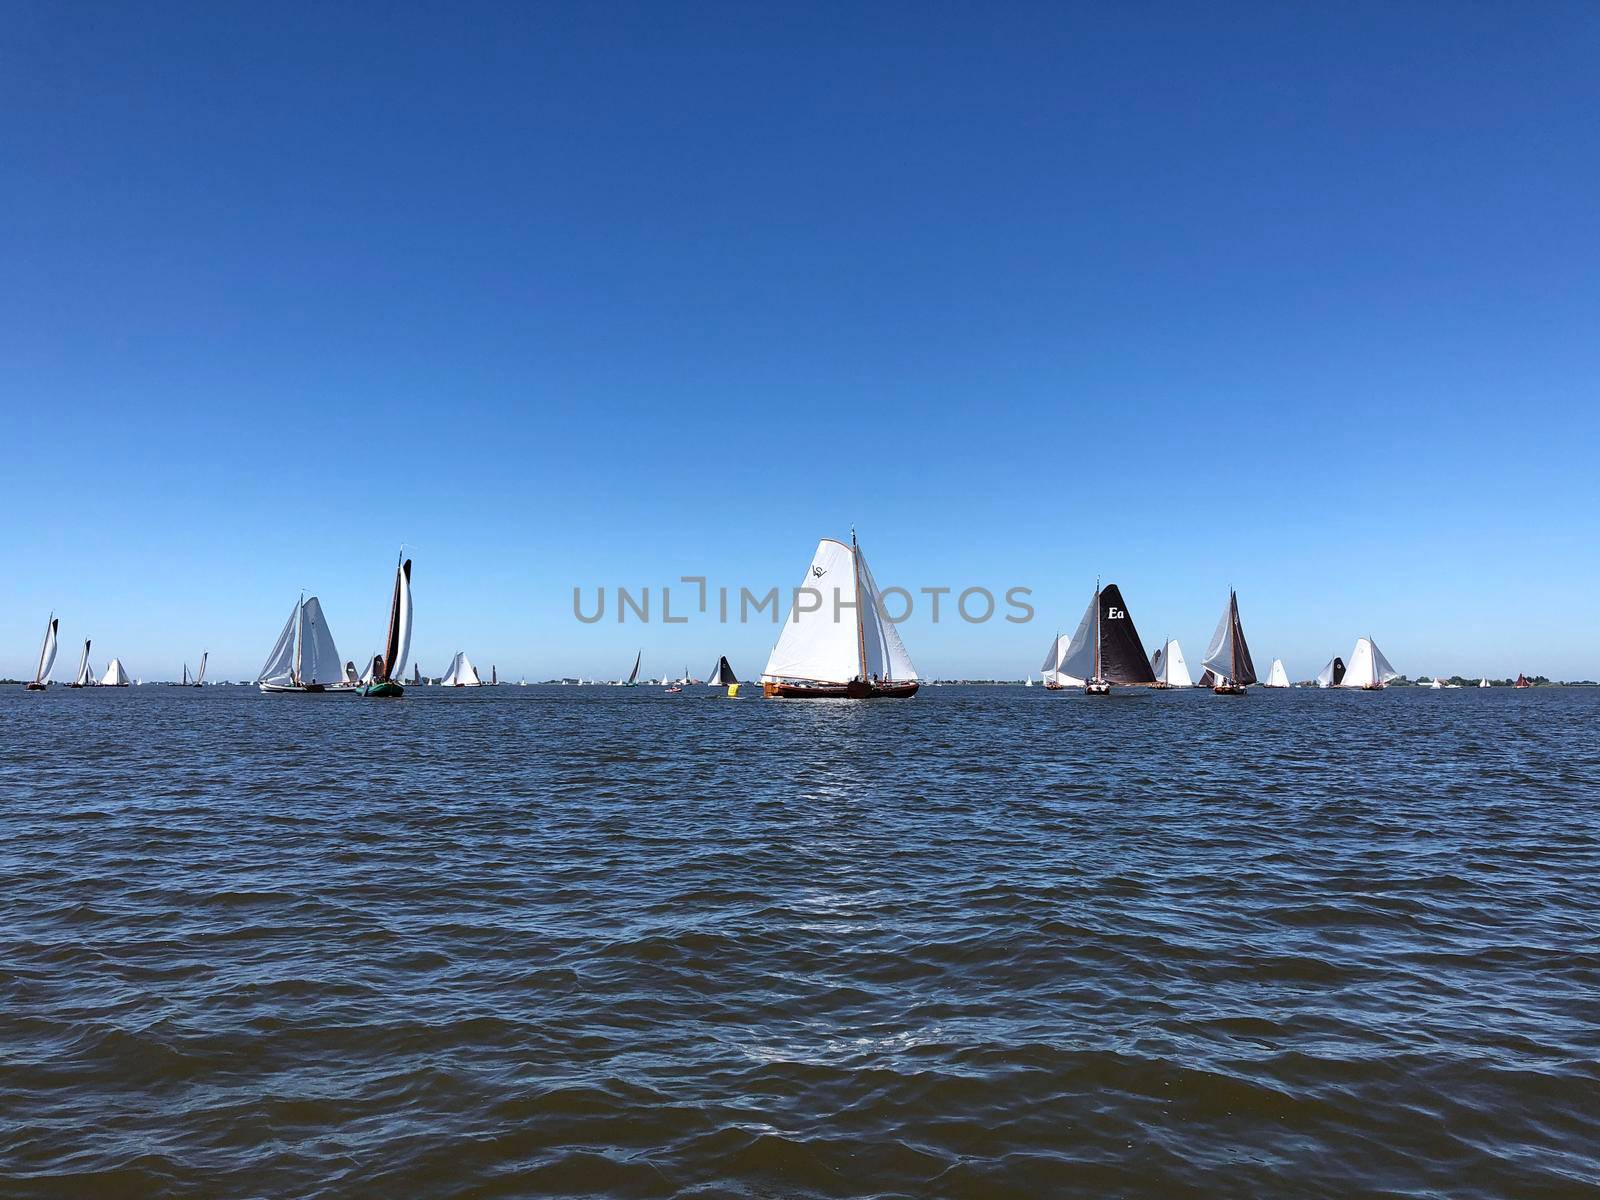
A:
[[0, 686, 1600, 1197]]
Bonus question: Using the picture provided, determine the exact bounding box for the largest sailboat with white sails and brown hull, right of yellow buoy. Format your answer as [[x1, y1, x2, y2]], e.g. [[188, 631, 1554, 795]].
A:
[[758, 530, 920, 699]]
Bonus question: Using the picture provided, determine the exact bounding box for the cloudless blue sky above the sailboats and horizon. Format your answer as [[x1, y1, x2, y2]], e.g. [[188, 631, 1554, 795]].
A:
[[0, 3, 1600, 678]]
